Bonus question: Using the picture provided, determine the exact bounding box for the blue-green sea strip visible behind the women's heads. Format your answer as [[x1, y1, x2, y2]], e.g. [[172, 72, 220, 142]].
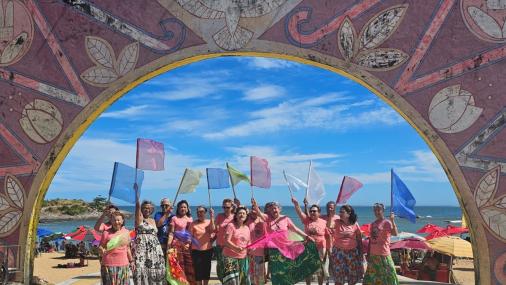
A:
[[38, 205, 462, 233]]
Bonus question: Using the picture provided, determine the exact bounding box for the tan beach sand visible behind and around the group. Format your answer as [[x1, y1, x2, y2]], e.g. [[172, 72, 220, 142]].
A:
[[34, 252, 474, 285]]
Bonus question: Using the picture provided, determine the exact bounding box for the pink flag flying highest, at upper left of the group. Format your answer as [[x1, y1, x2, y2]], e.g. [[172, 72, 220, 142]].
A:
[[136, 139, 165, 170]]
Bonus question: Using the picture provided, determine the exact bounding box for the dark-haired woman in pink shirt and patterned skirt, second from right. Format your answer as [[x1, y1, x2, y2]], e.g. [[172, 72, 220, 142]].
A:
[[329, 205, 364, 285]]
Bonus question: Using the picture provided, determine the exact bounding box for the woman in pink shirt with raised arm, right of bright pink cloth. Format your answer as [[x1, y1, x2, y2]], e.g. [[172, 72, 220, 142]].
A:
[[292, 197, 330, 285]]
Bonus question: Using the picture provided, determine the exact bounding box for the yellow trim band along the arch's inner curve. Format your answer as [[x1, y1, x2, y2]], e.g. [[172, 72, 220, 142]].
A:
[[24, 52, 470, 284]]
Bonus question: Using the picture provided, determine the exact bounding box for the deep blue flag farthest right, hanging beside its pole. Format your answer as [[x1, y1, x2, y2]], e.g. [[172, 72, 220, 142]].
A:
[[391, 169, 416, 223]]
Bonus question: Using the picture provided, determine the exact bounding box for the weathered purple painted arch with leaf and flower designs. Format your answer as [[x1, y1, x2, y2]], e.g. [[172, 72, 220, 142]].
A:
[[0, 0, 506, 284]]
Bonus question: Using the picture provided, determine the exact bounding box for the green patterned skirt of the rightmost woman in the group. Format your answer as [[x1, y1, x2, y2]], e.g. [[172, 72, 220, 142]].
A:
[[363, 255, 399, 285]]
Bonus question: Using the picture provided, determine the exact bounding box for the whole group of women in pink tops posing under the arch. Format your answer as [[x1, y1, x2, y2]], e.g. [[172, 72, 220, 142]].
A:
[[92, 189, 398, 285]]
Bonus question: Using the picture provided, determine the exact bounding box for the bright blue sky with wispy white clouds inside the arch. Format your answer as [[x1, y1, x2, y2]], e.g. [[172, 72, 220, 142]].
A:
[[46, 57, 458, 205]]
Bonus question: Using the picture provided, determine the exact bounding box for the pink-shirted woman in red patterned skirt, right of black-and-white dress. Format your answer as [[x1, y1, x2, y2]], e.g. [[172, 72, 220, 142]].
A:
[[167, 200, 195, 284]]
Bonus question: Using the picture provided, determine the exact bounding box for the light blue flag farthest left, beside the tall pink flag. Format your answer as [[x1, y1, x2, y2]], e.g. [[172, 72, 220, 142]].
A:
[[109, 162, 144, 204]]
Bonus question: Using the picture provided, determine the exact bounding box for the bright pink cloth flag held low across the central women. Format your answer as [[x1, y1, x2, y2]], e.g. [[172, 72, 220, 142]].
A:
[[248, 231, 304, 260]]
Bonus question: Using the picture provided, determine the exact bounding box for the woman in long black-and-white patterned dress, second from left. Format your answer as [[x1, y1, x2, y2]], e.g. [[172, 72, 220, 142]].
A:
[[133, 193, 165, 285]]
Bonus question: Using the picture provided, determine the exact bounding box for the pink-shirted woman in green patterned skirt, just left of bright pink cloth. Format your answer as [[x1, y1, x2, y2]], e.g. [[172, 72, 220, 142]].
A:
[[223, 207, 251, 285]]
